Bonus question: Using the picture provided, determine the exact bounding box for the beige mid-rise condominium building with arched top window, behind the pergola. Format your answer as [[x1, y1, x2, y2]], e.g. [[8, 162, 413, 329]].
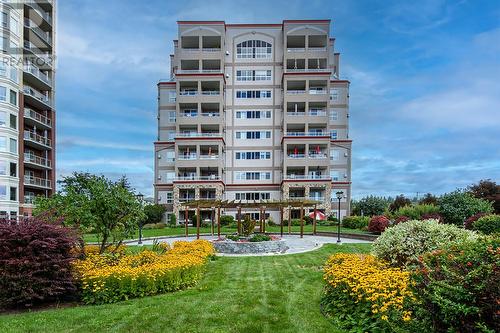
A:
[[154, 20, 352, 221]]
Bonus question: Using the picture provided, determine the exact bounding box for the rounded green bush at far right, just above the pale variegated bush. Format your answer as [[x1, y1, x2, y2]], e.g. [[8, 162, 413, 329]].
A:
[[439, 191, 493, 226]]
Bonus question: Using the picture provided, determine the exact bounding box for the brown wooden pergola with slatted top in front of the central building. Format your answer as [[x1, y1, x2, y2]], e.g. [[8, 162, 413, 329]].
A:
[[182, 199, 321, 239]]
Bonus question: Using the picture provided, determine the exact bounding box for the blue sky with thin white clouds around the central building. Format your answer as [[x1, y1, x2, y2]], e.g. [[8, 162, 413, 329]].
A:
[[56, 0, 500, 198]]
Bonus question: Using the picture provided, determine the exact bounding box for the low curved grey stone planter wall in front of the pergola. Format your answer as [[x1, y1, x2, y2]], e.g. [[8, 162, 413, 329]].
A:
[[212, 239, 288, 254]]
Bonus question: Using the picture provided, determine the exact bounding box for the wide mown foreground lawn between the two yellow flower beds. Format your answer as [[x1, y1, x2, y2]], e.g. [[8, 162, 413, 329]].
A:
[[0, 244, 370, 332]]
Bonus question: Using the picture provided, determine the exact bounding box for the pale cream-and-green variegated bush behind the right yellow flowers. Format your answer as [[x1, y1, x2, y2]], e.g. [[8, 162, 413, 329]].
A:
[[372, 220, 477, 267]]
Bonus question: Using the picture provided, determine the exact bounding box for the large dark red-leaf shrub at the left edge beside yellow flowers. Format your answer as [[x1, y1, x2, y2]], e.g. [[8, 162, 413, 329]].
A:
[[0, 219, 77, 308]]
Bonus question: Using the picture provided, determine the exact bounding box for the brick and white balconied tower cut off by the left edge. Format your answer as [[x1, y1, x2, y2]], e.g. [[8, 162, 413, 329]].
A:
[[0, 0, 55, 218]]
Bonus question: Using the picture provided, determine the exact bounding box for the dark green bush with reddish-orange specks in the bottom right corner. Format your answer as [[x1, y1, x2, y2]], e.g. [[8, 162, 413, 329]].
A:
[[412, 237, 500, 332]]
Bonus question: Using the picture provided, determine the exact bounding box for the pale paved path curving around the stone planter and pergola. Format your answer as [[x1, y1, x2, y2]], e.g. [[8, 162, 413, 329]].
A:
[[127, 235, 369, 257]]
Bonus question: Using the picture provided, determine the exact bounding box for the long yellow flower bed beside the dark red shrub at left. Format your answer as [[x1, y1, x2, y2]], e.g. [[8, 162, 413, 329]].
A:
[[74, 240, 214, 304]]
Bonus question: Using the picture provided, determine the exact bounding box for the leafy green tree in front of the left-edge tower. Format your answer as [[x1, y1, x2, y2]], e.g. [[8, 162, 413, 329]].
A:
[[34, 172, 145, 253]]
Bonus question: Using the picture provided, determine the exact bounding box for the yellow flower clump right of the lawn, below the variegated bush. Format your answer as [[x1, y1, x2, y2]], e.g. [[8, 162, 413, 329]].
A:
[[324, 253, 414, 321]]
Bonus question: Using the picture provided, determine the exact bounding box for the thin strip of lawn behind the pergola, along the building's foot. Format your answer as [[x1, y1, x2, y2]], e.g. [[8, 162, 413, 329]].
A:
[[83, 225, 367, 242]]
